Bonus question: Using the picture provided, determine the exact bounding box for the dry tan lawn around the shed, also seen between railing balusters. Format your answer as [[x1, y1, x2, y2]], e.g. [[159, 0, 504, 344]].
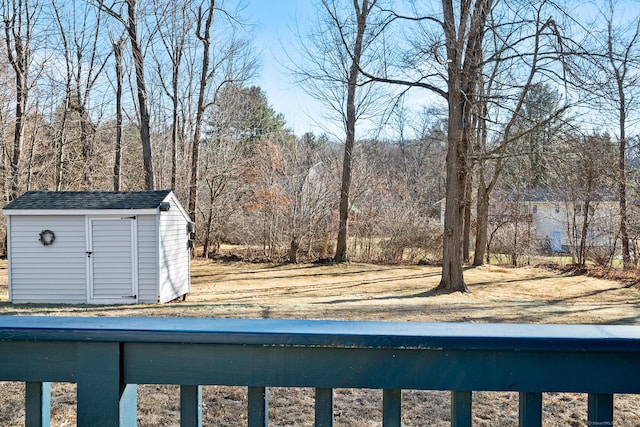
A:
[[0, 260, 640, 427]]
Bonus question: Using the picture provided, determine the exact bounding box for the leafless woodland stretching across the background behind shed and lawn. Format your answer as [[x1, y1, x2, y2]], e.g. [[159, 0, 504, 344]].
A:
[[0, 0, 640, 284]]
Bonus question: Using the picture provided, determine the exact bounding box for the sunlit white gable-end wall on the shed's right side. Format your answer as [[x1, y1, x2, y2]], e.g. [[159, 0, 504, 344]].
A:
[[159, 198, 190, 302]]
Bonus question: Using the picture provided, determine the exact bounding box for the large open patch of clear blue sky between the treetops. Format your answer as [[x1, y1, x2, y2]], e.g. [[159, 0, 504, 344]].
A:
[[243, 0, 328, 135]]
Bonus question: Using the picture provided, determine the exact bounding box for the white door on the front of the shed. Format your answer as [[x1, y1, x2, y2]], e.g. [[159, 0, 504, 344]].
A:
[[87, 217, 138, 303]]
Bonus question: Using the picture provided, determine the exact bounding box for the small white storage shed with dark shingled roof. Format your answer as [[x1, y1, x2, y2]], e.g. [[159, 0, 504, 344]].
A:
[[4, 190, 192, 304]]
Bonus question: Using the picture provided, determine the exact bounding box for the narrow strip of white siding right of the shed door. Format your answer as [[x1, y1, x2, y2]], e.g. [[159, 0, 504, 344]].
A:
[[138, 215, 159, 303]]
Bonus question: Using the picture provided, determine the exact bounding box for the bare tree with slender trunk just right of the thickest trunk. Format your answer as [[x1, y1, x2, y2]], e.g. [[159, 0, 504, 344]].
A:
[[473, 3, 569, 266]]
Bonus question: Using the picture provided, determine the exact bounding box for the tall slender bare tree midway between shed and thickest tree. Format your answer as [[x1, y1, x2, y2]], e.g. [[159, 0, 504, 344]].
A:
[[292, 0, 384, 262]]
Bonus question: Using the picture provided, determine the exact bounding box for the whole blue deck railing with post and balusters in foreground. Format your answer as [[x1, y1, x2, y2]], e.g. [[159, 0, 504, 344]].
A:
[[0, 316, 640, 426]]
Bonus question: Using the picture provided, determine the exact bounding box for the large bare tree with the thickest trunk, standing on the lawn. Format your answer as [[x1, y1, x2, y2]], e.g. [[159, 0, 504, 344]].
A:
[[352, 0, 576, 292]]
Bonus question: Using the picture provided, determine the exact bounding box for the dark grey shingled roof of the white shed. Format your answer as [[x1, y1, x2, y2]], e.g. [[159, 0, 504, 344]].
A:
[[4, 190, 171, 210]]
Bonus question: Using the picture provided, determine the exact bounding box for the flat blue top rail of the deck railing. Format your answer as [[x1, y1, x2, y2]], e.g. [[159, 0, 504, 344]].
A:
[[0, 316, 640, 352]]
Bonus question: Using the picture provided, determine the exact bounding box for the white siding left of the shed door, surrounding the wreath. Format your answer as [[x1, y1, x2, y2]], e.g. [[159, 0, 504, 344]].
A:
[[9, 215, 87, 304]]
